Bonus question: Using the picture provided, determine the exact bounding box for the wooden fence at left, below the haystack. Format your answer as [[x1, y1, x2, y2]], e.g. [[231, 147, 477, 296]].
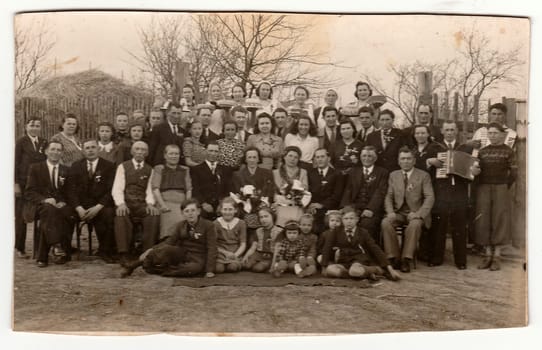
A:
[[15, 97, 152, 139]]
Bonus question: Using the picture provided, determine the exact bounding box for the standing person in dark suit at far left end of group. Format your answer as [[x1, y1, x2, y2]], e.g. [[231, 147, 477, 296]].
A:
[[15, 117, 47, 259]]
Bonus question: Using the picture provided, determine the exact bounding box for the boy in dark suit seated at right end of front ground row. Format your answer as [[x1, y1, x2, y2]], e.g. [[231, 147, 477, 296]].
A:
[[322, 207, 399, 281]]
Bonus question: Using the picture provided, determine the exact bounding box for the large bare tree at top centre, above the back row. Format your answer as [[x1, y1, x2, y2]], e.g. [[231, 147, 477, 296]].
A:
[[195, 14, 342, 95]]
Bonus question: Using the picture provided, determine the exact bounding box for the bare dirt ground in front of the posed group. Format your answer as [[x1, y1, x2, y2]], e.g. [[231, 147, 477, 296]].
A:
[[14, 230, 527, 334]]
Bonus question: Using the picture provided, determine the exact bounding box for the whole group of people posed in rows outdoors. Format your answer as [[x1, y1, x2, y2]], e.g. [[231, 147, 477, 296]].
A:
[[15, 82, 516, 280]]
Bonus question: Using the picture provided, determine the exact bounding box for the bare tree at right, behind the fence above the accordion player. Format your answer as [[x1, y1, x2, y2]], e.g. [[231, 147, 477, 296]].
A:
[[363, 27, 525, 123]]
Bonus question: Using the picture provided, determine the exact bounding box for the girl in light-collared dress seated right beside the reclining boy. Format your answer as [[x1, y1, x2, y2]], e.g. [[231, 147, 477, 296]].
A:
[[214, 197, 247, 273]]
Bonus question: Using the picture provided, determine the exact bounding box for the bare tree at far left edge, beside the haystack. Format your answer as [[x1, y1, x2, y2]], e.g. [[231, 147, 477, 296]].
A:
[[15, 19, 55, 94]]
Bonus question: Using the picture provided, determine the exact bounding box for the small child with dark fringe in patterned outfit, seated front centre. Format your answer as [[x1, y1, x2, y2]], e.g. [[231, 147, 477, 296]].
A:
[[272, 220, 308, 277]]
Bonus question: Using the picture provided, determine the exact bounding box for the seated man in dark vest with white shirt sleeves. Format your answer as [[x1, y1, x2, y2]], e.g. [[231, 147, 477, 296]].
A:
[[112, 141, 160, 265]]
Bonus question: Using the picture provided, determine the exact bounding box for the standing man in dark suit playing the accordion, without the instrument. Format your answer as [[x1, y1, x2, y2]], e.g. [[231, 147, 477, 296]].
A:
[[427, 120, 473, 270]]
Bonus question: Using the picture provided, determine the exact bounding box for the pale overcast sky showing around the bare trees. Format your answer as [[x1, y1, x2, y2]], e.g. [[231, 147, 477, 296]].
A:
[[16, 12, 529, 108]]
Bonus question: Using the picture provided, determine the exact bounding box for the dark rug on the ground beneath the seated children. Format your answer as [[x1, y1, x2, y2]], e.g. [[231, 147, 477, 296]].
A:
[[173, 271, 381, 288]]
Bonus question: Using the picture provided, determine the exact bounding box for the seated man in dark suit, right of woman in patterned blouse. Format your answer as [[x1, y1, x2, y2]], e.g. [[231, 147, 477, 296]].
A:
[[190, 142, 231, 220]]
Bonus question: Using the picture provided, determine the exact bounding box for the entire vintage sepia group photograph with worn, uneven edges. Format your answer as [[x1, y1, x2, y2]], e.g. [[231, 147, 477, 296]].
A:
[[10, 10, 531, 336]]
